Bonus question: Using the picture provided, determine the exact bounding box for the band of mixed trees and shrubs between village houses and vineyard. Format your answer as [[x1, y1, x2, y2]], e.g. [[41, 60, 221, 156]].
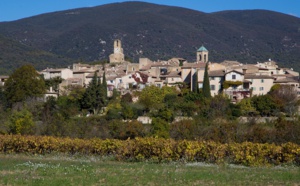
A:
[[0, 66, 300, 144]]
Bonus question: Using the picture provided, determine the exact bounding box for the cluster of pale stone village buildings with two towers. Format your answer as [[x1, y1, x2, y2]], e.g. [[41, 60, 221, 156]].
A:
[[40, 40, 300, 103]]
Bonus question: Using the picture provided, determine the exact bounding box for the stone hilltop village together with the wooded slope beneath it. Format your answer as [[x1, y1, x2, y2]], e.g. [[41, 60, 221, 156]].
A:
[[0, 40, 300, 143]]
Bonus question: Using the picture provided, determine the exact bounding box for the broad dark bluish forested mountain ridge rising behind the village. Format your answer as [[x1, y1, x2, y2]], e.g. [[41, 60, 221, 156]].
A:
[[0, 2, 300, 72]]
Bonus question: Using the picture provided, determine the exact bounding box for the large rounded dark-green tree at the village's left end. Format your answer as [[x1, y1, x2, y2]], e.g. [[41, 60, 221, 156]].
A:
[[4, 65, 46, 106]]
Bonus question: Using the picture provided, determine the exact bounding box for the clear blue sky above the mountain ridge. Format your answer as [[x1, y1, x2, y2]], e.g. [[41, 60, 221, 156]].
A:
[[0, 0, 300, 22]]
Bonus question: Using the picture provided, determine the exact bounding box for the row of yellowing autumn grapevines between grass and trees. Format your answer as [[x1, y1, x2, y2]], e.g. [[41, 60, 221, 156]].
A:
[[0, 135, 300, 166]]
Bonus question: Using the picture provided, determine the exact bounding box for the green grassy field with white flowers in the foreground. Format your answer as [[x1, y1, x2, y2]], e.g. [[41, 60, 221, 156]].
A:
[[0, 154, 300, 186]]
